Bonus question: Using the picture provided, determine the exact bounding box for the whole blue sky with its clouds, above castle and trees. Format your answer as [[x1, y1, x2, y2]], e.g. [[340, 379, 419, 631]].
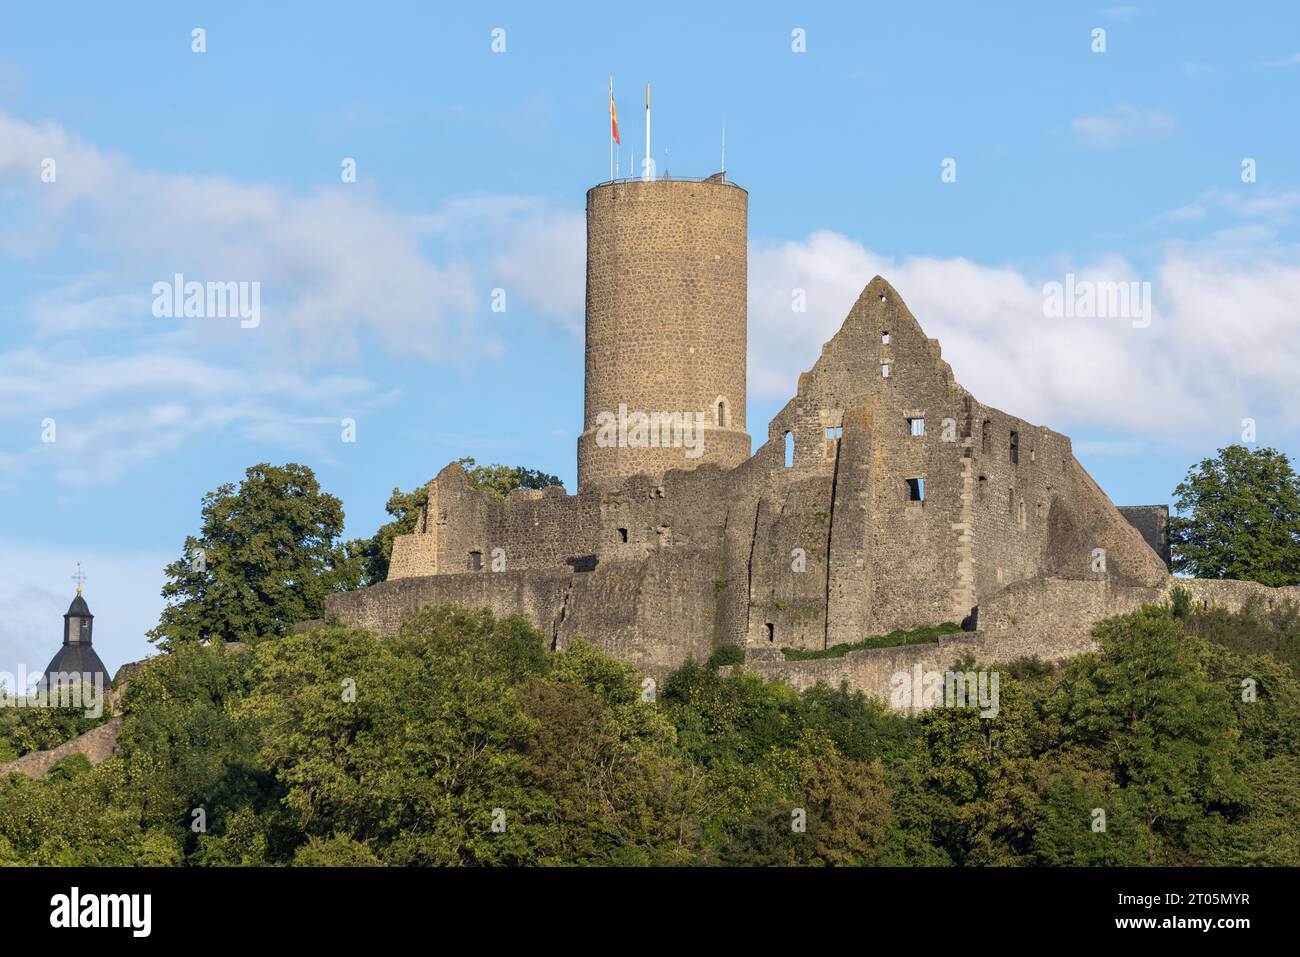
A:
[[0, 3, 1300, 671]]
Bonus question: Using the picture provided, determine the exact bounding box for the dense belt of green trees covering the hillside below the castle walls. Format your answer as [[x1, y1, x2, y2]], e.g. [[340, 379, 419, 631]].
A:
[[0, 606, 1300, 867]]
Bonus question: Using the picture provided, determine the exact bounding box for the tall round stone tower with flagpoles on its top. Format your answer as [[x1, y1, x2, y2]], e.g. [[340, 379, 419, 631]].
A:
[[577, 174, 750, 489]]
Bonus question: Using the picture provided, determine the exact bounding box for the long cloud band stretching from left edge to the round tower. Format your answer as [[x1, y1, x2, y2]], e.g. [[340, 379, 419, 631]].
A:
[[0, 111, 585, 363]]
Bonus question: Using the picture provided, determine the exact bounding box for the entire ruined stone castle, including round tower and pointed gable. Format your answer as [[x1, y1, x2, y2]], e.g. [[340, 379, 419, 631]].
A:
[[329, 177, 1289, 693]]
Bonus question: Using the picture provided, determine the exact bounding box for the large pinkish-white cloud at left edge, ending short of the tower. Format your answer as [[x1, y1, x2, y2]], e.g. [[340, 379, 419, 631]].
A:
[[0, 112, 481, 360]]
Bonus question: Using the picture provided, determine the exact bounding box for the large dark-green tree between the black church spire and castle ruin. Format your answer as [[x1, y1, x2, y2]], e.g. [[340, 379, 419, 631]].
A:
[[150, 463, 361, 649]]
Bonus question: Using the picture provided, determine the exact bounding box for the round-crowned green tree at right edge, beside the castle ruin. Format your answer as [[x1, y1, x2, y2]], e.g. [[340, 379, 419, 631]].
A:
[[1169, 445, 1300, 586]]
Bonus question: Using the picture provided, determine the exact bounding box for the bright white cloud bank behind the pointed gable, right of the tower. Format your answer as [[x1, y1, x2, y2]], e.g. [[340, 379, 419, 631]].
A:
[[749, 231, 1300, 439]]
